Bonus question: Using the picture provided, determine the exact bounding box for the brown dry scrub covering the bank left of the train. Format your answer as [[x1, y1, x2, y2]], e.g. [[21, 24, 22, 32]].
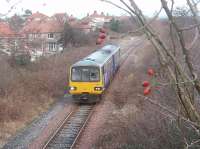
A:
[[0, 46, 96, 144]]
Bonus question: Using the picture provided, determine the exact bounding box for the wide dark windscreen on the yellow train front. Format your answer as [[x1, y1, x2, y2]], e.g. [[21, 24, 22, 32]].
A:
[[71, 67, 100, 82]]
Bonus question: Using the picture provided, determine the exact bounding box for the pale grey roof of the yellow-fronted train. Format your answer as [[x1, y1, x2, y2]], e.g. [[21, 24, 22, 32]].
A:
[[73, 45, 120, 66]]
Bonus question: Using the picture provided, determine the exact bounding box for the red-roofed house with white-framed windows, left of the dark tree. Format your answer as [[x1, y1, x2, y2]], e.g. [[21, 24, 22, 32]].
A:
[[21, 12, 67, 55]]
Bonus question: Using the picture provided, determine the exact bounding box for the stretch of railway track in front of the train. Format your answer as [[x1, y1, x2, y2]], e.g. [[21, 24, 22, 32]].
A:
[[43, 105, 94, 149]]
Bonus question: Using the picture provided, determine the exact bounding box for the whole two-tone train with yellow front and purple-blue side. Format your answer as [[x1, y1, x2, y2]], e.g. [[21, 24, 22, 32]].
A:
[[69, 45, 120, 99]]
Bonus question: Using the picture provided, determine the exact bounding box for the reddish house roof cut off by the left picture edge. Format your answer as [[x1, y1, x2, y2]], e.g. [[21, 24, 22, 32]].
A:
[[0, 22, 15, 37]]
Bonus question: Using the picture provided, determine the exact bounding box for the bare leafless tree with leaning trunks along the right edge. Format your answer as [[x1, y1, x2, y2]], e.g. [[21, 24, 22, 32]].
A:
[[102, 0, 200, 148]]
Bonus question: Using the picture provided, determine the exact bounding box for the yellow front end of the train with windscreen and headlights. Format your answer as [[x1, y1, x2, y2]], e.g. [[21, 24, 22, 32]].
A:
[[69, 66, 104, 100]]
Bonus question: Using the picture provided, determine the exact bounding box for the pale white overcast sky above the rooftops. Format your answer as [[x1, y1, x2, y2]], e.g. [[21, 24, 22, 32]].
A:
[[0, 0, 186, 18]]
